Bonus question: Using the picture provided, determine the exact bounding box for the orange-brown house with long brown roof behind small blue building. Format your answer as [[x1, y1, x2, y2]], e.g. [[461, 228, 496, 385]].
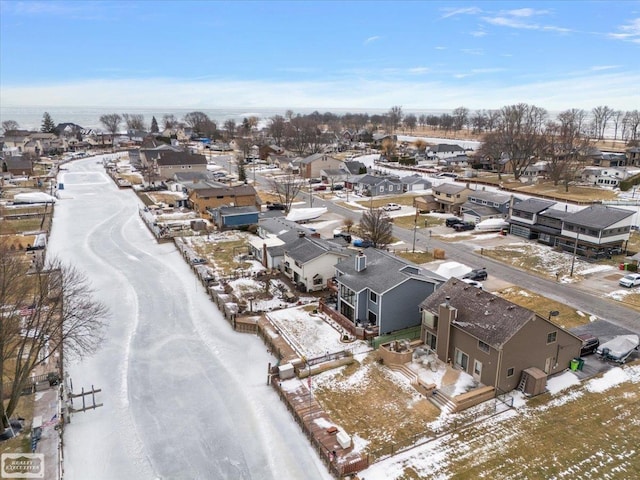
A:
[[184, 181, 260, 216]]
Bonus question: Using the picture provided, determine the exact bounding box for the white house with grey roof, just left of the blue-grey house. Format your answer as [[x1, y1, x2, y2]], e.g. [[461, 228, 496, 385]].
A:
[[281, 231, 354, 292]]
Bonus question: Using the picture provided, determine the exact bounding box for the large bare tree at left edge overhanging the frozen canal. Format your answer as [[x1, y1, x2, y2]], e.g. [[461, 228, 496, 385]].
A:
[[0, 246, 108, 427]]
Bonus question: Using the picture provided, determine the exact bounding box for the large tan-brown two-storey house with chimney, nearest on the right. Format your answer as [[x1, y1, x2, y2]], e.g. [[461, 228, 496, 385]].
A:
[[420, 278, 582, 392]]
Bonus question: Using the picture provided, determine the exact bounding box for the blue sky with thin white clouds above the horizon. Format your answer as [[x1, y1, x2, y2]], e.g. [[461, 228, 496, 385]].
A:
[[0, 0, 640, 111]]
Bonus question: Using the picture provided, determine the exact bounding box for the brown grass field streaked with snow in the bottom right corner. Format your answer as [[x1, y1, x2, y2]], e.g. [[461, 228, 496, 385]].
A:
[[359, 364, 640, 480]]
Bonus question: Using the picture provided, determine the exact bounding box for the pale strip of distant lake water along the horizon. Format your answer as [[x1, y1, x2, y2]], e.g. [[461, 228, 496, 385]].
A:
[[0, 105, 448, 130]]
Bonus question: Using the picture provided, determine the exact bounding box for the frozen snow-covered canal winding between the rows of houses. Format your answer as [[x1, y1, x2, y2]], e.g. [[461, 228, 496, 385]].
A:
[[49, 158, 331, 480]]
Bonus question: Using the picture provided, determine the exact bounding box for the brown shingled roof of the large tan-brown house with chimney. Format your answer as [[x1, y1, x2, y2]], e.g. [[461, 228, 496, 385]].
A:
[[420, 278, 536, 348]]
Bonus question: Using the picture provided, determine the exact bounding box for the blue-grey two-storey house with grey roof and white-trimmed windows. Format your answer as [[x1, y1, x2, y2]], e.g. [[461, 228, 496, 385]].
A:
[[335, 248, 444, 334]]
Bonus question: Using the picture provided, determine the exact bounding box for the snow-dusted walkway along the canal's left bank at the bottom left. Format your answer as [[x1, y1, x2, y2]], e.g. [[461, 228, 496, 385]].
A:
[[31, 385, 62, 480]]
